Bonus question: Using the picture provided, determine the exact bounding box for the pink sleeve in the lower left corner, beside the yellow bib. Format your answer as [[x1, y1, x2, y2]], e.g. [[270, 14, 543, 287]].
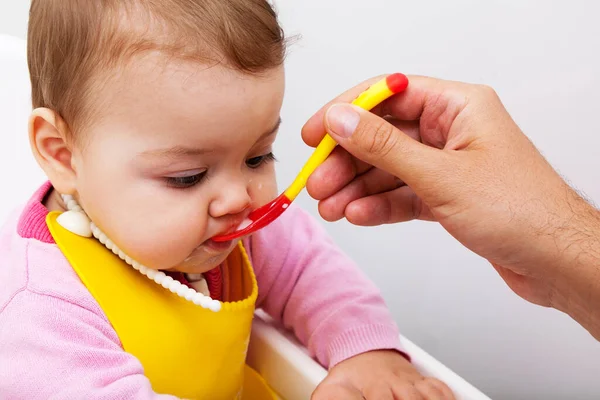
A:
[[0, 289, 175, 400]]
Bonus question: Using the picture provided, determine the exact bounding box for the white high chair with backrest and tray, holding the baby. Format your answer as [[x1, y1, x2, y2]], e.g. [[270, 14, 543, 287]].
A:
[[0, 35, 490, 400]]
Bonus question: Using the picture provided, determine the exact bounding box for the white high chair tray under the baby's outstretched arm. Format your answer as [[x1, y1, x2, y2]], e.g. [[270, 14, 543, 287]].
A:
[[248, 310, 490, 400]]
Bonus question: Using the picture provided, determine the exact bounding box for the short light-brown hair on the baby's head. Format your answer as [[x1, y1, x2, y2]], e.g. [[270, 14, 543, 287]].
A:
[[27, 0, 286, 136]]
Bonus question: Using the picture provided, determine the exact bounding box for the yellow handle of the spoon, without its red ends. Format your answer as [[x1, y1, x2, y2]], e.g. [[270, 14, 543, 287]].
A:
[[284, 78, 394, 201]]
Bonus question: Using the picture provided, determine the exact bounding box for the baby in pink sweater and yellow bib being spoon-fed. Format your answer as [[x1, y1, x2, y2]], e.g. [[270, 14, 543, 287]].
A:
[[0, 0, 452, 400]]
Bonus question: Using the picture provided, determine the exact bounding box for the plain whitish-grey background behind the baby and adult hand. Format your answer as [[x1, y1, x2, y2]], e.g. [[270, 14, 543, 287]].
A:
[[0, 0, 600, 400]]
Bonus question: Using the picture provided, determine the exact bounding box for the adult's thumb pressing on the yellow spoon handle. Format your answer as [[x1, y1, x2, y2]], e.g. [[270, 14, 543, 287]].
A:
[[325, 104, 441, 186]]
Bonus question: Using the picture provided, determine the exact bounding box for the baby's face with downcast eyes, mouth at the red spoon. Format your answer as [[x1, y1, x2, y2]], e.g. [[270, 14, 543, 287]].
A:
[[73, 55, 284, 273]]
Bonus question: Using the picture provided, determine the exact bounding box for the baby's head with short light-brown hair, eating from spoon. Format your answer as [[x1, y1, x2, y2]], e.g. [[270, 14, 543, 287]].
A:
[[28, 0, 285, 272]]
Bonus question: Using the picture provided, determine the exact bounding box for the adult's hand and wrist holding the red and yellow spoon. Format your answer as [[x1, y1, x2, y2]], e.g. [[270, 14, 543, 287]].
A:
[[302, 76, 600, 338]]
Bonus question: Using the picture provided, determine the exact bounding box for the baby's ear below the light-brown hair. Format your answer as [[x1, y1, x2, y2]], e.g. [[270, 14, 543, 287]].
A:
[[29, 108, 76, 194]]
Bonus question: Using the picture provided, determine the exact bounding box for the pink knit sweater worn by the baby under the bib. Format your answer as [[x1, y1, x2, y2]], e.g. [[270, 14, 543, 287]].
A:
[[0, 184, 400, 400]]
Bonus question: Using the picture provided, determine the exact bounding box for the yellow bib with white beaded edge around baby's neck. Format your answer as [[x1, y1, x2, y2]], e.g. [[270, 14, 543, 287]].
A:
[[46, 212, 276, 400]]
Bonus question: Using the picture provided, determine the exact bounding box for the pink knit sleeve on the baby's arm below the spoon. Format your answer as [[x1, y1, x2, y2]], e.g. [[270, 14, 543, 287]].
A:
[[248, 206, 401, 368]]
